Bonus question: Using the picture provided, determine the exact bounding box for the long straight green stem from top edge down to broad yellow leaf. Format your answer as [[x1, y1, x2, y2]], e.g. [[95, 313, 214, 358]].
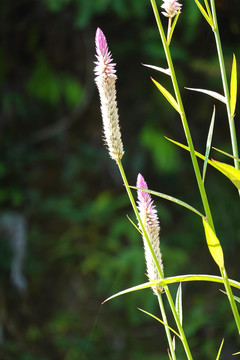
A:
[[151, 0, 214, 230]]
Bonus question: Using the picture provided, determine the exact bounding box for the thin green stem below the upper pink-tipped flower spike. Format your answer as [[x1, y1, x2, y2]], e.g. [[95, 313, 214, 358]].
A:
[[117, 160, 193, 360]]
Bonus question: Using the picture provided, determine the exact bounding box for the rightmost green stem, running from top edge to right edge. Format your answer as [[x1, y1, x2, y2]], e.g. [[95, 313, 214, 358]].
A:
[[211, 0, 240, 169]]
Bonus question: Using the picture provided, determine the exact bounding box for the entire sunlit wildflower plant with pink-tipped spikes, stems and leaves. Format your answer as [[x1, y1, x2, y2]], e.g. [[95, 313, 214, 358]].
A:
[[95, 0, 240, 360]]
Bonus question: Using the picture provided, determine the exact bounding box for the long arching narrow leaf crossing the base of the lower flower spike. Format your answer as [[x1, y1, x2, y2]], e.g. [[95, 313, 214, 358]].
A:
[[102, 274, 240, 304]]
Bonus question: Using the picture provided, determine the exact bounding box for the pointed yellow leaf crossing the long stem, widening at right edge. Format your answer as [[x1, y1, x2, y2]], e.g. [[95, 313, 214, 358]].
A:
[[165, 136, 240, 190]]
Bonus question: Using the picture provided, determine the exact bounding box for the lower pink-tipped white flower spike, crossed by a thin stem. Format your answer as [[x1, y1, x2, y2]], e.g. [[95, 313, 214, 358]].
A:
[[136, 174, 163, 295]]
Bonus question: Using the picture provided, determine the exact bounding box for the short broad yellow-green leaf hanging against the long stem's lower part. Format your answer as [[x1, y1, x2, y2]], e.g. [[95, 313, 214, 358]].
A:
[[203, 218, 224, 269]]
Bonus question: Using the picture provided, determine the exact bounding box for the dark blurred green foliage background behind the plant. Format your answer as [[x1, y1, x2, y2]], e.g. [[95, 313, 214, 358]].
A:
[[0, 0, 240, 360]]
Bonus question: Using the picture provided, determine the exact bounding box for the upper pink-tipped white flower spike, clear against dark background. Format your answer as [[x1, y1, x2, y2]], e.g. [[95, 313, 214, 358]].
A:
[[94, 28, 124, 162]]
